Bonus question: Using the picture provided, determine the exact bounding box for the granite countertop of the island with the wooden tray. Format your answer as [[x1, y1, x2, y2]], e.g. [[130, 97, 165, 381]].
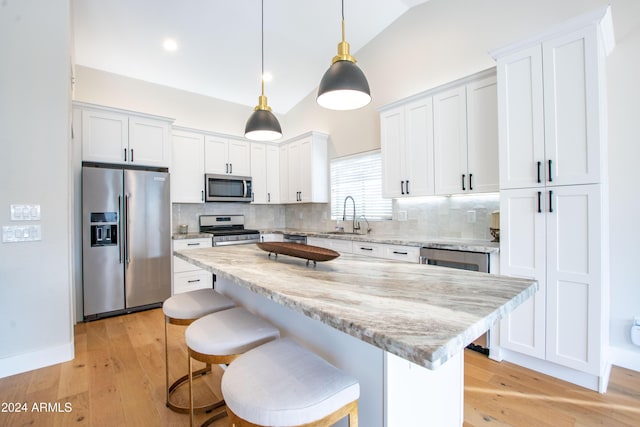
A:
[[174, 245, 538, 369]]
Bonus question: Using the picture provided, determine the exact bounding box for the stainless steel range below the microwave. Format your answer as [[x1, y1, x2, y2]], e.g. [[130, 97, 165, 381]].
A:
[[199, 215, 260, 246]]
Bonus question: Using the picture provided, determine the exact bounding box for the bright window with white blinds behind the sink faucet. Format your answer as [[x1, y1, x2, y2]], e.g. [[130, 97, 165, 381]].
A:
[[330, 150, 391, 220]]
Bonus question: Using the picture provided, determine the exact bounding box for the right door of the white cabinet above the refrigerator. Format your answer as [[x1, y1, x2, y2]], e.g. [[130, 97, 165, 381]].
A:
[[128, 117, 171, 167]]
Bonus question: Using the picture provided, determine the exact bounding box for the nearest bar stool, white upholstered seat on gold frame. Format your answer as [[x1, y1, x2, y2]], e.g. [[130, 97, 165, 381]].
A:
[[222, 338, 360, 427]]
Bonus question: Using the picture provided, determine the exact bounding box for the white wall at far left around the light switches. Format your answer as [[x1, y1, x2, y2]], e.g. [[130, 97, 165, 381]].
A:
[[0, 0, 73, 377]]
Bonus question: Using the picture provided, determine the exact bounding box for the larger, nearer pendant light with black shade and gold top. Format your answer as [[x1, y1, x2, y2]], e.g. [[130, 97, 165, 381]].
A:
[[316, 0, 371, 110]]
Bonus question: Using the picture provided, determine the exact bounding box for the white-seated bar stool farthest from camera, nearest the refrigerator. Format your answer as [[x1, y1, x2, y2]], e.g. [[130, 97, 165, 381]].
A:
[[162, 288, 235, 414]]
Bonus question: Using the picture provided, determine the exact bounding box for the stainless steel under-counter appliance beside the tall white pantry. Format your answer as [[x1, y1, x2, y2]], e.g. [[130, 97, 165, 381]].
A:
[[420, 248, 491, 355]]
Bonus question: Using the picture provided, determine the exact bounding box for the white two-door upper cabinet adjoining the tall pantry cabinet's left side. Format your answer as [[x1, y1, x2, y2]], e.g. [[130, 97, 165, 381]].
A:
[[433, 76, 499, 195]]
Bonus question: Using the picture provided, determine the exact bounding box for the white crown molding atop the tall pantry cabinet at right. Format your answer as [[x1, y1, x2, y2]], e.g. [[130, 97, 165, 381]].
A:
[[489, 5, 616, 59]]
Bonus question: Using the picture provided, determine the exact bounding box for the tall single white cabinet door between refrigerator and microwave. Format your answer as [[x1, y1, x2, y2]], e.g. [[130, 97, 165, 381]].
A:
[[171, 131, 204, 203]]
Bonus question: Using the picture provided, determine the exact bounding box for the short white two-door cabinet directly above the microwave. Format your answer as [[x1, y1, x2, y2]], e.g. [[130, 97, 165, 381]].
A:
[[204, 135, 251, 176]]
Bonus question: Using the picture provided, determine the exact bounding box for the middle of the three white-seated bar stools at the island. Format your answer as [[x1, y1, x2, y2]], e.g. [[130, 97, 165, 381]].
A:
[[184, 307, 280, 426]]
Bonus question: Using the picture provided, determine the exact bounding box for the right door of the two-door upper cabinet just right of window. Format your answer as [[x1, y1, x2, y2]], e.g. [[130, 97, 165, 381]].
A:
[[403, 97, 435, 196]]
